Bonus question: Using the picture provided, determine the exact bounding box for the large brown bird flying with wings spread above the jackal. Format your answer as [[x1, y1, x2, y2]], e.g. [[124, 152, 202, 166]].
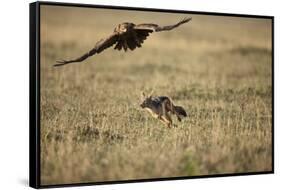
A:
[[54, 18, 191, 66]]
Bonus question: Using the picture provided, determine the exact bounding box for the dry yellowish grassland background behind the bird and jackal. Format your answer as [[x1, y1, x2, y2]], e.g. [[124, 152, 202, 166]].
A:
[[41, 6, 272, 185]]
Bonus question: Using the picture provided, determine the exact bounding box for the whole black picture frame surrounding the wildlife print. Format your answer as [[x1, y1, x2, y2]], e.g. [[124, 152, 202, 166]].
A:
[[29, 1, 274, 188]]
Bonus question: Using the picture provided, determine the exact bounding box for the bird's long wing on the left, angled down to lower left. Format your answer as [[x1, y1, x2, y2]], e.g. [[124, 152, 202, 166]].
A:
[[54, 33, 118, 67]]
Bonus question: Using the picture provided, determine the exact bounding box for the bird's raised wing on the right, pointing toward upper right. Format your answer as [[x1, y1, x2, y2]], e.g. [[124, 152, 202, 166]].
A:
[[134, 17, 192, 32]]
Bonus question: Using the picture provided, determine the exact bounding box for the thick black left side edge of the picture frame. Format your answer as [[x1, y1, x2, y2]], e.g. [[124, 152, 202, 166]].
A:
[[29, 2, 41, 188]]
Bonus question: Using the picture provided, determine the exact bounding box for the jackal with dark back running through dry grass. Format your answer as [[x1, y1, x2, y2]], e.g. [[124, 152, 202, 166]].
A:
[[140, 93, 187, 127]]
